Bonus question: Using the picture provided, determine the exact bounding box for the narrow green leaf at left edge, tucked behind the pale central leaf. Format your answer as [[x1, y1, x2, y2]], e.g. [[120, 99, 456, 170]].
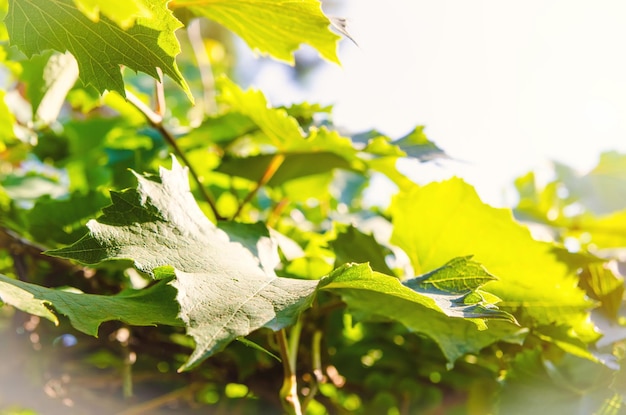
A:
[[0, 275, 182, 336]]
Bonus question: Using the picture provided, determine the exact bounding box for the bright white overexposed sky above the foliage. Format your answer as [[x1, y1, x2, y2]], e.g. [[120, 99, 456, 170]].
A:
[[246, 0, 626, 205]]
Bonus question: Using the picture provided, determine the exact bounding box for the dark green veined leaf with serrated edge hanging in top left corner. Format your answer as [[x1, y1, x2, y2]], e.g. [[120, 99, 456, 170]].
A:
[[5, 0, 193, 100]]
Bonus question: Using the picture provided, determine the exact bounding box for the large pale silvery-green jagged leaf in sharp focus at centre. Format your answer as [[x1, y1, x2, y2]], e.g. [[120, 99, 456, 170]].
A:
[[48, 160, 317, 369]]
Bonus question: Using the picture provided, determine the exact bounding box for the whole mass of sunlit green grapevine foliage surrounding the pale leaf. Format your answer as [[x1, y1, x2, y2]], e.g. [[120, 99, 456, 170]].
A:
[[0, 0, 626, 414]]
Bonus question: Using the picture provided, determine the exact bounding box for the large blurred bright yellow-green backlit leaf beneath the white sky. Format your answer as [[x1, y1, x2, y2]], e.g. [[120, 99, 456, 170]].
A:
[[391, 179, 593, 338]]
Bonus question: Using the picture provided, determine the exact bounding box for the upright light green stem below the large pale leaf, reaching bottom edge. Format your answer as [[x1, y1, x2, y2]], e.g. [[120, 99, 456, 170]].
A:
[[276, 324, 302, 415]]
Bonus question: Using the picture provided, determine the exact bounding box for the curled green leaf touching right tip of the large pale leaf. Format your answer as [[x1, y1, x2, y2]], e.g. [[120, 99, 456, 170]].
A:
[[320, 264, 524, 363]]
